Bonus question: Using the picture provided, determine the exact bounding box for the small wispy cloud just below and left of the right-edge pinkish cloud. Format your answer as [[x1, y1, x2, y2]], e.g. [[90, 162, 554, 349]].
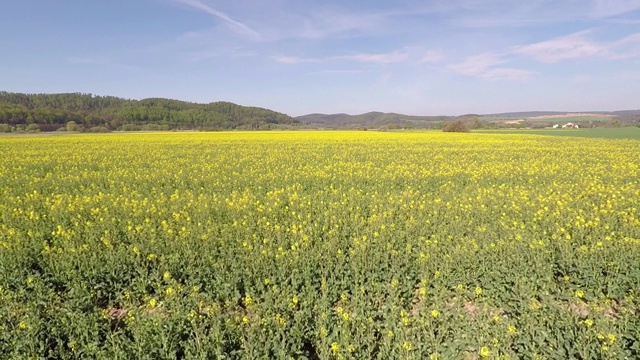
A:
[[446, 53, 532, 81]]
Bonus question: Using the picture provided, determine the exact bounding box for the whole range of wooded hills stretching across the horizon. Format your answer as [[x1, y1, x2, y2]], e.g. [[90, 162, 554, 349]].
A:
[[0, 91, 640, 132]]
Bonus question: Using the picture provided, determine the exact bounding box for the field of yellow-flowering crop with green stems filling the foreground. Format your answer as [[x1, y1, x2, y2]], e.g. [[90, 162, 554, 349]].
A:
[[0, 131, 640, 359]]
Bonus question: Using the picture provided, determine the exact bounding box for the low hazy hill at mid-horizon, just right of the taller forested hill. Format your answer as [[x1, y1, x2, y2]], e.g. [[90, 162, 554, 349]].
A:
[[295, 111, 452, 128]]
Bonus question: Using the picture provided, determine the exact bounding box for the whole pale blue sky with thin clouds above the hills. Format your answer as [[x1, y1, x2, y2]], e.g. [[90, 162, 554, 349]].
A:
[[0, 0, 640, 116]]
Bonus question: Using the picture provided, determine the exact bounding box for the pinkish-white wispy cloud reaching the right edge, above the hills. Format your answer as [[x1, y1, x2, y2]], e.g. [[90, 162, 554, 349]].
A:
[[513, 30, 640, 63]]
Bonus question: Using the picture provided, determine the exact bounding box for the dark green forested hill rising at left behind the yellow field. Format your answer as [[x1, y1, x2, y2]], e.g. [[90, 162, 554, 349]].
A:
[[0, 91, 299, 131]]
